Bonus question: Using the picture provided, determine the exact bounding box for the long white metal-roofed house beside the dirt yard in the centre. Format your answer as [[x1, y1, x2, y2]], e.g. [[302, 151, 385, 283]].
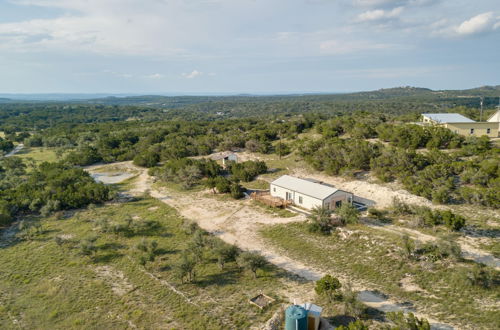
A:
[[270, 175, 354, 210]]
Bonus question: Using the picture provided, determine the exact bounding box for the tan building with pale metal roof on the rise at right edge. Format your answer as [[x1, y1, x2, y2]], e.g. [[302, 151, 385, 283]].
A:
[[422, 113, 499, 137]]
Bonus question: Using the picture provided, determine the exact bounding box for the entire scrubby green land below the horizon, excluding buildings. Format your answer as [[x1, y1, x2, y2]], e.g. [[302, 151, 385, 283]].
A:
[[0, 88, 500, 329]]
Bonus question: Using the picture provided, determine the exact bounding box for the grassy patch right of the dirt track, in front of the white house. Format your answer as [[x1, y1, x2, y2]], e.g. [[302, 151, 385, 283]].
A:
[[262, 223, 500, 329]]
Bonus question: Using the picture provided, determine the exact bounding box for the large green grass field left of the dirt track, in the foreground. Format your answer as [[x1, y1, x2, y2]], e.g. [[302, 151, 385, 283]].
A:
[[0, 199, 287, 329]]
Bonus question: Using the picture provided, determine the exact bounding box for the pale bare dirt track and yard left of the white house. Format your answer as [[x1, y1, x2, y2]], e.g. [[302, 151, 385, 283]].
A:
[[87, 162, 460, 329]]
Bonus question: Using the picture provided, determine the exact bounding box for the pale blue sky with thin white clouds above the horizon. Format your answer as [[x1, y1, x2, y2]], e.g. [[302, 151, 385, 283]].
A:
[[0, 0, 500, 94]]
